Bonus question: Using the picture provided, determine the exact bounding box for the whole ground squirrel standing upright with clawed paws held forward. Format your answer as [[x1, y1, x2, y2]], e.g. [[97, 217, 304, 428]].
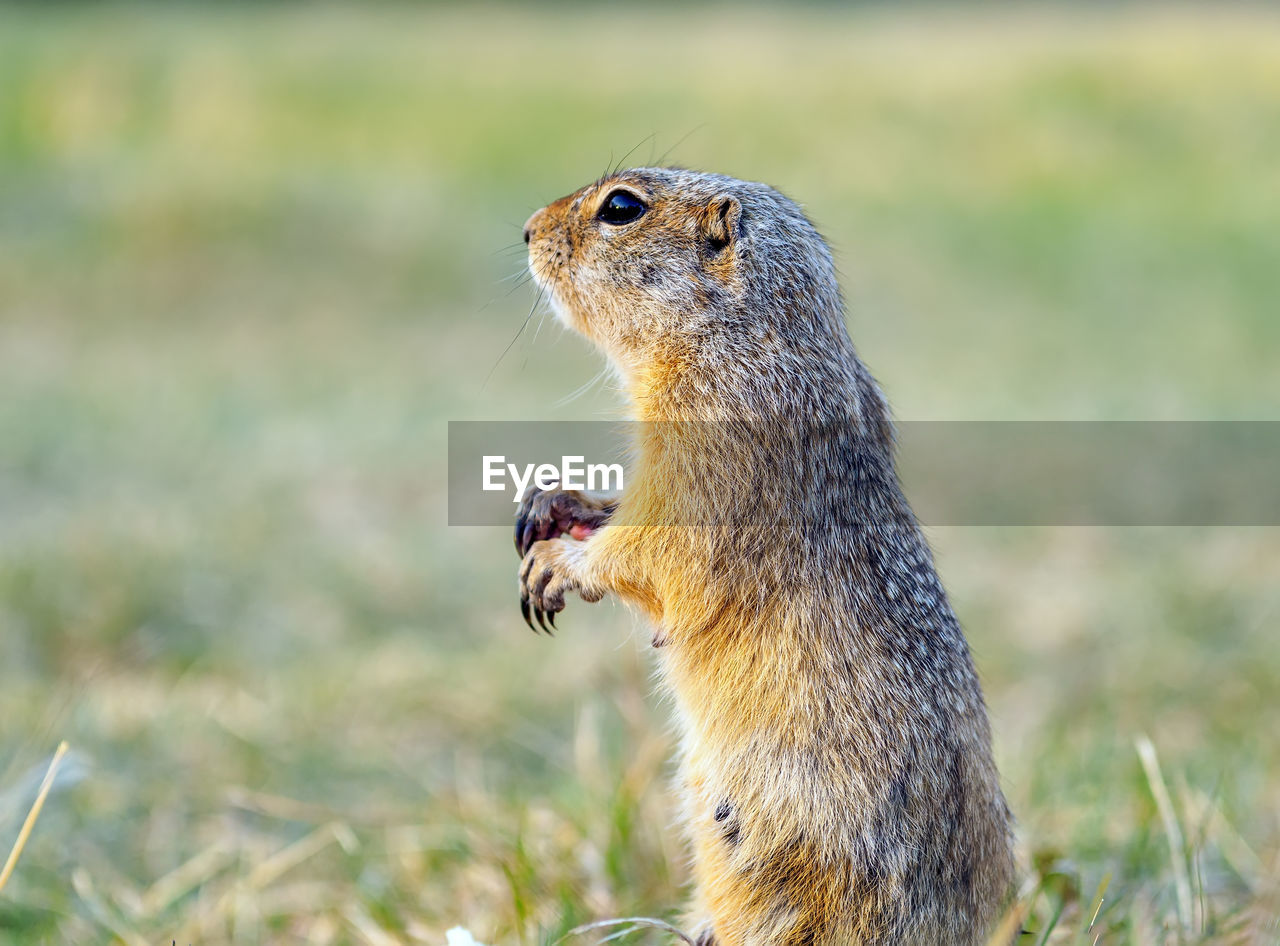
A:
[[516, 168, 1014, 946]]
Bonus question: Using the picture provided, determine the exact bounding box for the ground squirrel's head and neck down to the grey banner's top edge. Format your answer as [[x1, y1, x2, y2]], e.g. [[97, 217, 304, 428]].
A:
[[525, 168, 888, 440]]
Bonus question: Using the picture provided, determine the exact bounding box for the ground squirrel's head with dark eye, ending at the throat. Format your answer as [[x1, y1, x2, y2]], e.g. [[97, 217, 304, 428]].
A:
[[525, 168, 845, 378]]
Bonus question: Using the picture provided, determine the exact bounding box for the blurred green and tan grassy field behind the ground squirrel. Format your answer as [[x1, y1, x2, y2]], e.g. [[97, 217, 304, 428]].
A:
[[0, 4, 1280, 946]]
